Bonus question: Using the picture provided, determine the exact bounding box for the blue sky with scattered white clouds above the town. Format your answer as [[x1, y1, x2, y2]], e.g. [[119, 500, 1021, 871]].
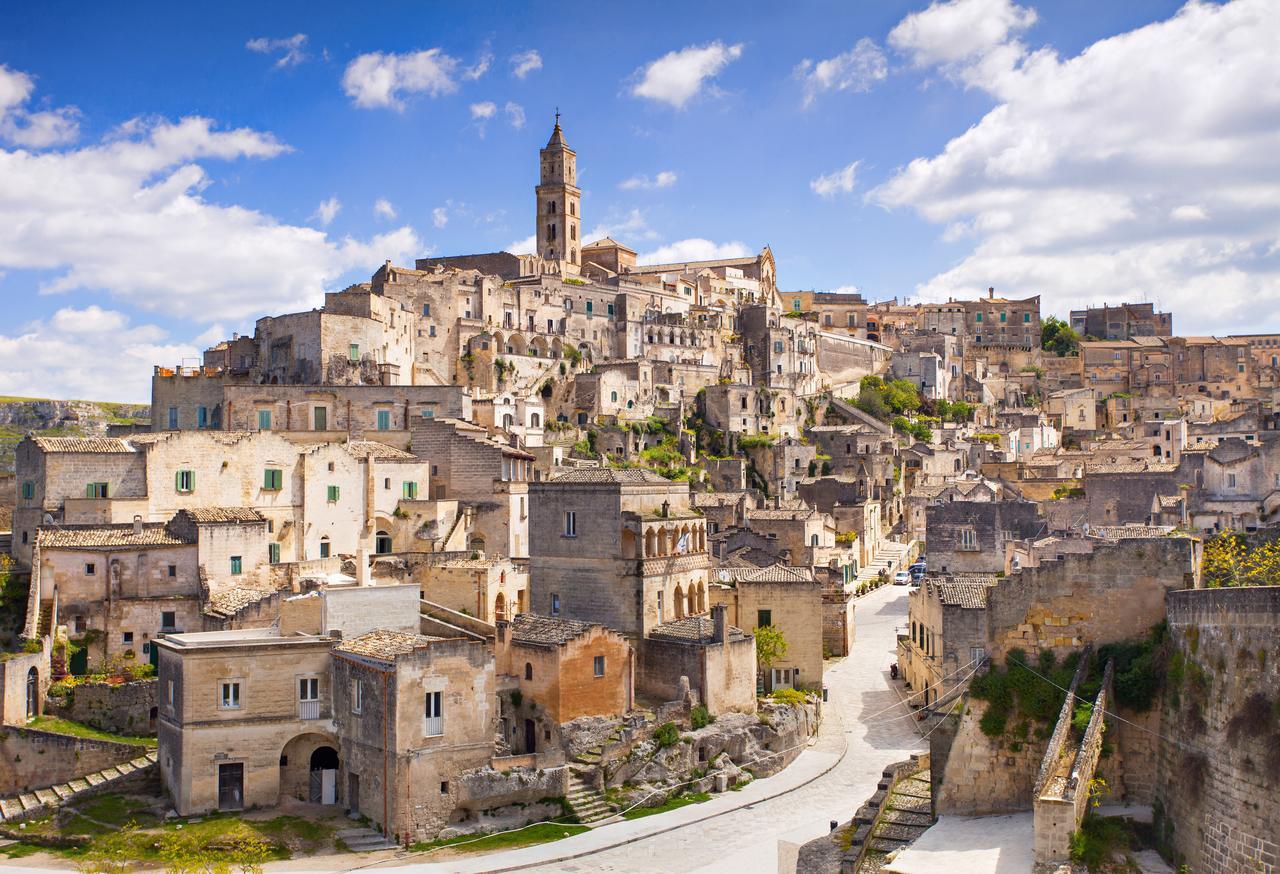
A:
[[0, 0, 1280, 402]]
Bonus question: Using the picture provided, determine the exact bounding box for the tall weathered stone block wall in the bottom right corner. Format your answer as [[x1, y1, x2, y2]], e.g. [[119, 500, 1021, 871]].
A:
[[1153, 586, 1280, 874]]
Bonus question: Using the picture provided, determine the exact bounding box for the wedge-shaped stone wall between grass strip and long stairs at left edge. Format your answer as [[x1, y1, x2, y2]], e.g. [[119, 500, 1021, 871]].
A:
[[0, 726, 143, 796]]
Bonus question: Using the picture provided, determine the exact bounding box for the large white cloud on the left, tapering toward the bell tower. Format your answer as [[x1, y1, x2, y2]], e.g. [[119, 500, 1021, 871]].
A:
[[0, 74, 422, 327]]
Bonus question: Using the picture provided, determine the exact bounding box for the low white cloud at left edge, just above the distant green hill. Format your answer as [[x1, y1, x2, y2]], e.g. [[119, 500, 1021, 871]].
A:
[[0, 306, 200, 403]]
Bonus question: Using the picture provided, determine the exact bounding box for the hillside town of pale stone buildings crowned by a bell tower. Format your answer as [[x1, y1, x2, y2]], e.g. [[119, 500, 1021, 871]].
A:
[[0, 114, 1280, 874]]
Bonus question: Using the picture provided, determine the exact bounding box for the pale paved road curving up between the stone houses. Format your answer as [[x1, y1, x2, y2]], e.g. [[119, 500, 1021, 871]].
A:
[[373, 586, 923, 874]]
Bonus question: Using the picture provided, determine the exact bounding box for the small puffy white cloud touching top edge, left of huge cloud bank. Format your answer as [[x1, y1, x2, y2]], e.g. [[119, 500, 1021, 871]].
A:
[[888, 0, 1036, 67]]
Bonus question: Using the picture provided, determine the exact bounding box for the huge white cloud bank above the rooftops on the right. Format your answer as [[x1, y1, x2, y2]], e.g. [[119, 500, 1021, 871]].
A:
[[869, 0, 1280, 334]]
